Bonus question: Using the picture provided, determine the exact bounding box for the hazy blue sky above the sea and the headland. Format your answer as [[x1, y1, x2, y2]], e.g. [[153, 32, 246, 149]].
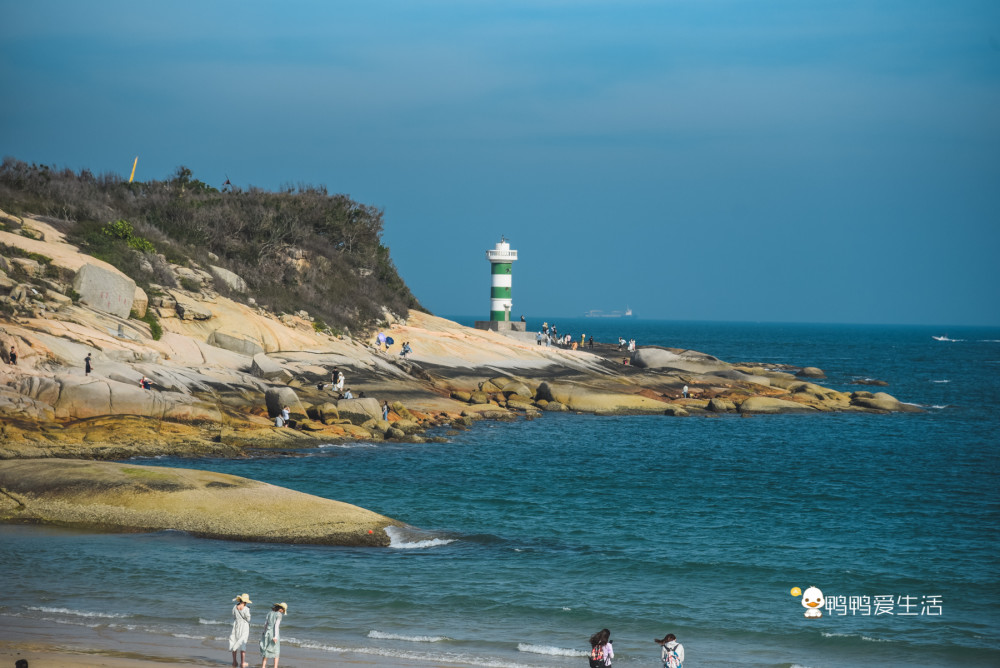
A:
[[0, 0, 1000, 326]]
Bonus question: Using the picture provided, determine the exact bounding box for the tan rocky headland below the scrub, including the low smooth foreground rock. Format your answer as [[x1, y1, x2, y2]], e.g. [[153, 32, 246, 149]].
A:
[[0, 212, 917, 545]]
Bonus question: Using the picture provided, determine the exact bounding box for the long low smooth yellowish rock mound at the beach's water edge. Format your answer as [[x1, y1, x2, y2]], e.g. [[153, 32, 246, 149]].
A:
[[0, 458, 398, 546]]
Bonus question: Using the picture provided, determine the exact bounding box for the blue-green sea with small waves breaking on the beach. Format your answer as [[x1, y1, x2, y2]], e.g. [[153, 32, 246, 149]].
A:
[[0, 317, 1000, 668]]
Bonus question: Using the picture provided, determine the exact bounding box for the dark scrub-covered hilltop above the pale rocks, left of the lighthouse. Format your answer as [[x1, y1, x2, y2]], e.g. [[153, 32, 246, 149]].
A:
[[0, 158, 421, 330]]
